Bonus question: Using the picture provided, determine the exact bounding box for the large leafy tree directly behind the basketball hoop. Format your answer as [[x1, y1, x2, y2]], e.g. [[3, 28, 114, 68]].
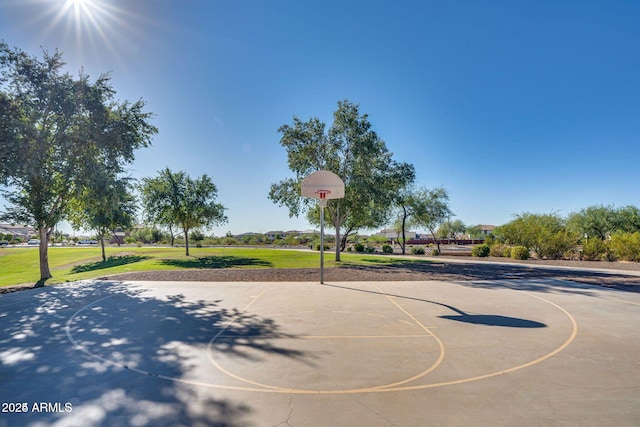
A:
[[269, 100, 415, 261]]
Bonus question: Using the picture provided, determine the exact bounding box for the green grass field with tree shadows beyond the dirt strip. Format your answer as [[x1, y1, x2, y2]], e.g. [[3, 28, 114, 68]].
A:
[[0, 246, 424, 286]]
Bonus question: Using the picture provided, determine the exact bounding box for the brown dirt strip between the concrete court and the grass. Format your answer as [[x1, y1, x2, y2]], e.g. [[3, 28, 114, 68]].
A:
[[5, 257, 640, 293]]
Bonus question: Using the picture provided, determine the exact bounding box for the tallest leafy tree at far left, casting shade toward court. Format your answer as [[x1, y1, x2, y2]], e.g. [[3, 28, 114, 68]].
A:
[[0, 42, 157, 284]]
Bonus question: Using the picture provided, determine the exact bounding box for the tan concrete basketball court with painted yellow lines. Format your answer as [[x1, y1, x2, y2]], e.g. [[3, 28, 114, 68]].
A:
[[0, 280, 640, 426]]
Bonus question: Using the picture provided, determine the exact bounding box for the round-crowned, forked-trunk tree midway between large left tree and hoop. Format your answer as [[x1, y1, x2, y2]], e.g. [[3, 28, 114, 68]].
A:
[[140, 168, 227, 256]]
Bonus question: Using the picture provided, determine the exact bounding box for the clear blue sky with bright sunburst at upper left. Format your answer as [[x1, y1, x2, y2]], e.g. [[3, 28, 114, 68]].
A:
[[0, 0, 640, 236]]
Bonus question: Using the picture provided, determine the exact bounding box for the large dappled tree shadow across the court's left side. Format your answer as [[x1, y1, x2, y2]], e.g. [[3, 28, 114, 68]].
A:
[[0, 282, 313, 426]]
